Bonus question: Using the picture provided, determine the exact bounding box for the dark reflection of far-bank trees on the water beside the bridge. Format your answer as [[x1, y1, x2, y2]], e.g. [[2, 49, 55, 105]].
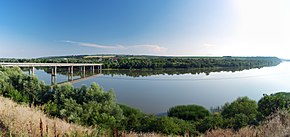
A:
[[102, 67, 260, 77]]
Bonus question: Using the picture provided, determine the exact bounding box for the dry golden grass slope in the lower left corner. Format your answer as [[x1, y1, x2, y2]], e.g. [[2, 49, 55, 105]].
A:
[[0, 96, 104, 137]]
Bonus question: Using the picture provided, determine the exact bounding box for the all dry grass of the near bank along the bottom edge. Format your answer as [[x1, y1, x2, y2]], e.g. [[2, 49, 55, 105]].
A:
[[0, 96, 290, 137]]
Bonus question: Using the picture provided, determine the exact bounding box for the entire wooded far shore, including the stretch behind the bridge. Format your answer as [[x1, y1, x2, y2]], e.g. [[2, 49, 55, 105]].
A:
[[0, 55, 281, 69]]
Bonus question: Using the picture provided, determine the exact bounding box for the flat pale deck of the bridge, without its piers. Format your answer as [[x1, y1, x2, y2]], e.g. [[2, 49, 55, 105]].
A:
[[0, 63, 103, 67]]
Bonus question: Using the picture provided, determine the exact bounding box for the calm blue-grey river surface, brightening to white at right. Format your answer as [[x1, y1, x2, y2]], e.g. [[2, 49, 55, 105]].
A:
[[31, 62, 290, 114]]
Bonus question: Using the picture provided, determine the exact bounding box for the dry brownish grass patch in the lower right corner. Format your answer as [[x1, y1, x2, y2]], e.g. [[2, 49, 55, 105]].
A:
[[203, 111, 290, 137]]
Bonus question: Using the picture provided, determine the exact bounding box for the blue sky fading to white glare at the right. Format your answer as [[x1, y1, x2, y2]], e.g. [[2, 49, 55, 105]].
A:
[[0, 0, 290, 59]]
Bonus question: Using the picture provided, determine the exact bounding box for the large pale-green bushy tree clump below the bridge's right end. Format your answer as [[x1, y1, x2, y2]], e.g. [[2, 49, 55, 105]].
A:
[[44, 83, 123, 127]]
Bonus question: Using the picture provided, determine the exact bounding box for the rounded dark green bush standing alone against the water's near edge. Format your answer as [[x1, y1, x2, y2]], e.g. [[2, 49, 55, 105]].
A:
[[168, 105, 210, 121]]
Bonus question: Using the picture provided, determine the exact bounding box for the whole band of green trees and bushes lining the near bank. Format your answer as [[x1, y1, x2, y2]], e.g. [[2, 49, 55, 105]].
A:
[[0, 67, 290, 136]]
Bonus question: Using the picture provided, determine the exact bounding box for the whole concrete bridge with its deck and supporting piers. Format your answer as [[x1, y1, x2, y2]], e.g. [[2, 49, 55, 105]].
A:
[[0, 62, 103, 85]]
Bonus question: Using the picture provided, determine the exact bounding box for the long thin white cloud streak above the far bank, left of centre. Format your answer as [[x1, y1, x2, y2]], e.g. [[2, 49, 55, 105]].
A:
[[61, 40, 168, 54]]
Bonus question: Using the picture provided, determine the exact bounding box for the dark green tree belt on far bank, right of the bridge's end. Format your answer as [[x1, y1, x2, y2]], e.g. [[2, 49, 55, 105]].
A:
[[103, 56, 280, 69]]
